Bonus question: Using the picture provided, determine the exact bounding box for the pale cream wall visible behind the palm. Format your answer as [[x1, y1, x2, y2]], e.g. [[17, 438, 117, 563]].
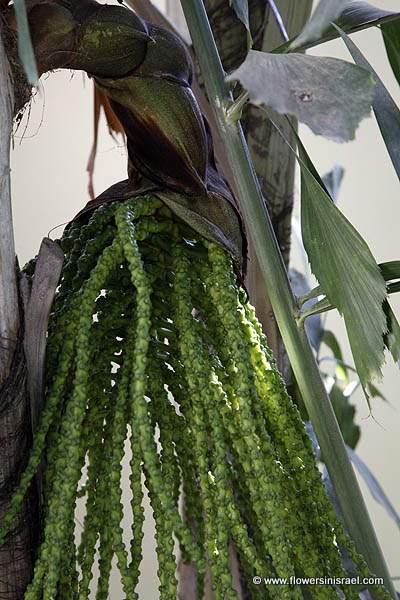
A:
[[12, 0, 400, 600]]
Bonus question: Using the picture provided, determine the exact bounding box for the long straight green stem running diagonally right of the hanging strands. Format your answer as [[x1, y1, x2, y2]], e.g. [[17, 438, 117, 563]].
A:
[[181, 0, 396, 598]]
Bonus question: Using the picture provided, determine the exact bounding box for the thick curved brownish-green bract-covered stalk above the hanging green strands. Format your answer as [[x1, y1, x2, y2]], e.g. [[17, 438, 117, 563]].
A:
[[17, 0, 244, 265]]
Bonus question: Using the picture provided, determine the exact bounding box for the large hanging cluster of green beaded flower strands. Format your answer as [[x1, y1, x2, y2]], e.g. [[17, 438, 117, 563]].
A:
[[0, 196, 386, 600]]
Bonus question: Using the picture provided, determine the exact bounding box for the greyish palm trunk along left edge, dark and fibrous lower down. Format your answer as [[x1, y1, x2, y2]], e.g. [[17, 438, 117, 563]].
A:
[[0, 21, 37, 600]]
